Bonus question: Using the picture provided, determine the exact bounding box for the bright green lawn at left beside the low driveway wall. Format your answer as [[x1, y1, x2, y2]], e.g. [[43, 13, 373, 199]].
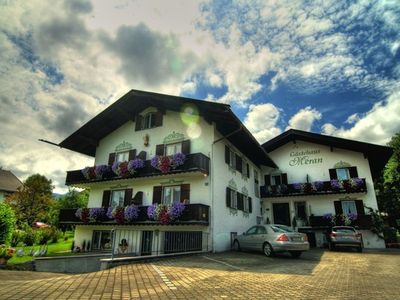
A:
[[8, 231, 75, 265]]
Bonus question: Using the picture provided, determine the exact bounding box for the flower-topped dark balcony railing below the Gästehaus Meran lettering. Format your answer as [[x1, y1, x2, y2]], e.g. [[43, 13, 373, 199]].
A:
[[260, 178, 367, 198]]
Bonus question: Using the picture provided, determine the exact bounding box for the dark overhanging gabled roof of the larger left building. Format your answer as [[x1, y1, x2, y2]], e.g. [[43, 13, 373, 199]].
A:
[[59, 90, 276, 167]]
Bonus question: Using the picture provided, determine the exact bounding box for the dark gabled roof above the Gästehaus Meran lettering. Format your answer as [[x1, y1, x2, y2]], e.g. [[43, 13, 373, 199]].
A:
[[262, 129, 393, 178]]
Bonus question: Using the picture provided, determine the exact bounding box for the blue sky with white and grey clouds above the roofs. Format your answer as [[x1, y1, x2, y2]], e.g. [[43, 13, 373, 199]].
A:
[[0, 0, 400, 192]]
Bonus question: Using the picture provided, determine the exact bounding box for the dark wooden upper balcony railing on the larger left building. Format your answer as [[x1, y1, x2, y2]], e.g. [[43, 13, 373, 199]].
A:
[[65, 153, 210, 185]]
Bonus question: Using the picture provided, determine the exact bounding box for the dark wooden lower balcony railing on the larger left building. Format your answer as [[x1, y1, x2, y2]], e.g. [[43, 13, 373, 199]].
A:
[[59, 204, 210, 225]]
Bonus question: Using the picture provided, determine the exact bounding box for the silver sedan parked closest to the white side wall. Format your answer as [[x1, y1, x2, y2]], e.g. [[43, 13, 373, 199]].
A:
[[233, 224, 310, 258]]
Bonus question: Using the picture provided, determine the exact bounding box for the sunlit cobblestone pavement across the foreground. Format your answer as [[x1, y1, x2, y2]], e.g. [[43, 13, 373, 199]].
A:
[[0, 250, 400, 299]]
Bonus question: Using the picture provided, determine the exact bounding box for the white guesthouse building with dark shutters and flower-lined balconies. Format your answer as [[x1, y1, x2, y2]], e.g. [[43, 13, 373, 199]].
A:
[[60, 90, 387, 255]]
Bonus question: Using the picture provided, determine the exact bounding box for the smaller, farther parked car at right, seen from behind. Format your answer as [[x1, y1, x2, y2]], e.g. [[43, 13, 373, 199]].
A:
[[328, 226, 363, 252]]
